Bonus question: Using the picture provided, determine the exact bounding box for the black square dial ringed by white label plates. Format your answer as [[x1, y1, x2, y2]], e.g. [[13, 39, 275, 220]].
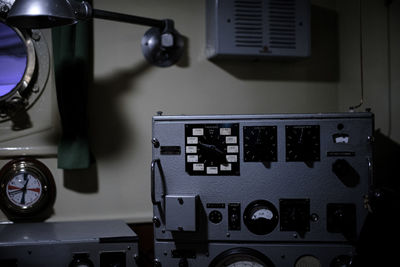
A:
[[185, 123, 240, 175]]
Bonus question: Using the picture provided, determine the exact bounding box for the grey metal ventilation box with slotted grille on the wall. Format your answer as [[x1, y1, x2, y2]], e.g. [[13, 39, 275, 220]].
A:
[[206, 0, 310, 59]]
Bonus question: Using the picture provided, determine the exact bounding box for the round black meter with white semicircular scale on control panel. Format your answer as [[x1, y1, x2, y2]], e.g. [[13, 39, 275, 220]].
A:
[[243, 200, 279, 235]]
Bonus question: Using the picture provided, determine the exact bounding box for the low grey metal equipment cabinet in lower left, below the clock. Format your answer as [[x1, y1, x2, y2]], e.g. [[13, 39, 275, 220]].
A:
[[0, 221, 138, 267]]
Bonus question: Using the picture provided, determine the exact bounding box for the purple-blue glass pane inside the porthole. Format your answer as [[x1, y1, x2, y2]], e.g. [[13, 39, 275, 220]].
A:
[[0, 21, 28, 98]]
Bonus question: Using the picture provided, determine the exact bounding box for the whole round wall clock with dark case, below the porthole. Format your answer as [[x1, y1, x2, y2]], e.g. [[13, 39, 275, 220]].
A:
[[0, 158, 56, 221]]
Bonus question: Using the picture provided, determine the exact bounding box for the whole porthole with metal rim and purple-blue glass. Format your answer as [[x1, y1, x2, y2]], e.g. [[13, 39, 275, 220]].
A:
[[0, 19, 50, 122]]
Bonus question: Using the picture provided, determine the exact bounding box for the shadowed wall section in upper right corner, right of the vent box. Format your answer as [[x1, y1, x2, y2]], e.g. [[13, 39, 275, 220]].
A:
[[337, 0, 400, 143]]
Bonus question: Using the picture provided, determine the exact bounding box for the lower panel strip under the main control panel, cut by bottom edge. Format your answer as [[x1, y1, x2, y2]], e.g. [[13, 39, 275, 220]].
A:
[[155, 241, 353, 267]]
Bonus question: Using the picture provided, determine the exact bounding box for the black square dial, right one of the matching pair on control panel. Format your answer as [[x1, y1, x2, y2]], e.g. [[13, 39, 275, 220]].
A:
[[286, 125, 320, 162]]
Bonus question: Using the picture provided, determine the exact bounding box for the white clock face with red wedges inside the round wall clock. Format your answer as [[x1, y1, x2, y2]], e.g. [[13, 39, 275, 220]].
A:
[[6, 173, 43, 208]]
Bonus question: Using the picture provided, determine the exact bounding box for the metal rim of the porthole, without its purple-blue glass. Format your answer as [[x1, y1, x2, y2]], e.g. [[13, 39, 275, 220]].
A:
[[0, 18, 50, 122]]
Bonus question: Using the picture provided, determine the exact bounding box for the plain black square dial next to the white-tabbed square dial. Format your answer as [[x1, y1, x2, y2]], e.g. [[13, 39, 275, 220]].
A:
[[243, 126, 277, 162]]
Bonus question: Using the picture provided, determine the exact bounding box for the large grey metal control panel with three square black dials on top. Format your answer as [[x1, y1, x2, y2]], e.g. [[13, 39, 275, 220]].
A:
[[151, 112, 374, 266]]
